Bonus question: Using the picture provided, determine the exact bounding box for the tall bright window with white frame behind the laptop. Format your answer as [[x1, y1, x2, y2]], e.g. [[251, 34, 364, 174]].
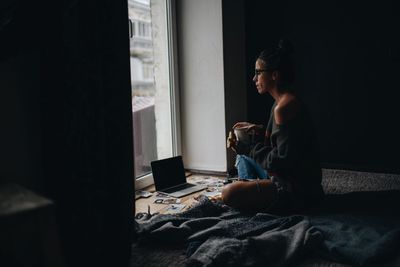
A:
[[128, 0, 180, 188]]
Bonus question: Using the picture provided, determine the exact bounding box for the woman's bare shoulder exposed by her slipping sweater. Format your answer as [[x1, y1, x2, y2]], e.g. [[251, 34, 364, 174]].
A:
[[274, 93, 303, 125]]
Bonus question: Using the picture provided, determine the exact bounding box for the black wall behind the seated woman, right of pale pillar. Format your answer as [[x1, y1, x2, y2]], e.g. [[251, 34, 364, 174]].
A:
[[245, 0, 400, 173]]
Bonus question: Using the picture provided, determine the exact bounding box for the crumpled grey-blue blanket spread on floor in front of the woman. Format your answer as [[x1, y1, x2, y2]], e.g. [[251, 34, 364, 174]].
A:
[[136, 197, 400, 266]]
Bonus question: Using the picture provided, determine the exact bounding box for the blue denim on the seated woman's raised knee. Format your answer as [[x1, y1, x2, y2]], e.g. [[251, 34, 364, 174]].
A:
[[235, 155, 269, 179]]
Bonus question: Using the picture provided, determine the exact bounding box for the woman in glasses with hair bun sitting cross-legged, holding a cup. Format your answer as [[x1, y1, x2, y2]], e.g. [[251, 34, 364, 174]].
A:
[[222, 40, 324, 212]]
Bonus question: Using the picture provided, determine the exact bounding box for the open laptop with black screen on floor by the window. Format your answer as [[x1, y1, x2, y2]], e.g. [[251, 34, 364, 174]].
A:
[[150, 156, 207, 198]]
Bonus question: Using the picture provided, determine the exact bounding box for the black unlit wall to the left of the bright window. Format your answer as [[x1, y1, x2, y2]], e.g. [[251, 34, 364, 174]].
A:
[[0, 0, 134, 266]]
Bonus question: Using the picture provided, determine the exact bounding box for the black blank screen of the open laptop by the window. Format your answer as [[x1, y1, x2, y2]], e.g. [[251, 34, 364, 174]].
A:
[[151, 156, 186, 191]]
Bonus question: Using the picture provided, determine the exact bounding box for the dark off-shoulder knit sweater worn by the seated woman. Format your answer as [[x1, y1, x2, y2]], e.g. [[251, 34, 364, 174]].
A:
[[249, 103, 323, 205]]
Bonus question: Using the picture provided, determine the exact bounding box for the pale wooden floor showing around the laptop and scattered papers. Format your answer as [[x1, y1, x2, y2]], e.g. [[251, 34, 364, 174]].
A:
[[135, 174, 225, 214]]
